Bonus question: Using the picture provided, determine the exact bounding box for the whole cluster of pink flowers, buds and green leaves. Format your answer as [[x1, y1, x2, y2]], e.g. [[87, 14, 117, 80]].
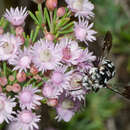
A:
[[0, 0, 115, 130]]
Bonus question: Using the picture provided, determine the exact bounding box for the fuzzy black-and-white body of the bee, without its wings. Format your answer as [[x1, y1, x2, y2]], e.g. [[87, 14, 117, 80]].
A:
[[82, 58, 115, 92]]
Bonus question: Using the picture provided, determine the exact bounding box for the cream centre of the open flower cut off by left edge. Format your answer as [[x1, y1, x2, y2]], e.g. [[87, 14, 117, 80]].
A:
[[2, 42, 14, 54]]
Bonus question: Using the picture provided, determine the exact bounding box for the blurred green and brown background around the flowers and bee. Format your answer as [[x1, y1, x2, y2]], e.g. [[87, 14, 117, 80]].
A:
[[0, 0, 130, 130]]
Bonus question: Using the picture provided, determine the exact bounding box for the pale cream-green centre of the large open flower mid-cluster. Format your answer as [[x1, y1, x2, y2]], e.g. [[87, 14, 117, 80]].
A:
[[40, 49, 52, 62]]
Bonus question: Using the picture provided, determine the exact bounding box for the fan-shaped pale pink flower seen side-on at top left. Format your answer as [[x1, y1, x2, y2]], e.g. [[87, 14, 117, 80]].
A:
[[4, 7, 28, 26]]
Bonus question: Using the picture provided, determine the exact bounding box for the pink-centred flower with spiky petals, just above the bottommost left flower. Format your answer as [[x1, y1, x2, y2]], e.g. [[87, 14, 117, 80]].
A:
[[16, 85, 43, 110]]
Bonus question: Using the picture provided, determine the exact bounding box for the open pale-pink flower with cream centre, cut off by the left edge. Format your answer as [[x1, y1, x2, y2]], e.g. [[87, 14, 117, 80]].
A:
[[0, 33, 22, 60]]
